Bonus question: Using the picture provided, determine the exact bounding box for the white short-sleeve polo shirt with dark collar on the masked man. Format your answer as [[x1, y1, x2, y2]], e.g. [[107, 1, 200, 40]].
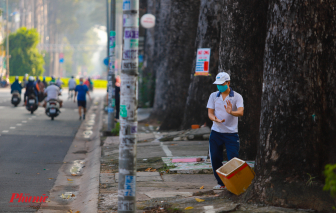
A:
[[207, 88, 244, 133]]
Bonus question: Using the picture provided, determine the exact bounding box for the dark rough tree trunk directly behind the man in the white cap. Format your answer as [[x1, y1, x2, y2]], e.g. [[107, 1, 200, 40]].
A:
[[218, 0, 267, 160]]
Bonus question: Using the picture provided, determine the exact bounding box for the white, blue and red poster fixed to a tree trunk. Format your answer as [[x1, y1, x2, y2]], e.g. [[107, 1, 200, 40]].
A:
[[195, 48, 211, 76]]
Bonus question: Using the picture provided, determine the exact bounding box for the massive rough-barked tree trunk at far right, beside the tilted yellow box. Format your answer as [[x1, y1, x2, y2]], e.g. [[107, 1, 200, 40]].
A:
[[245, 0, 336, 211]]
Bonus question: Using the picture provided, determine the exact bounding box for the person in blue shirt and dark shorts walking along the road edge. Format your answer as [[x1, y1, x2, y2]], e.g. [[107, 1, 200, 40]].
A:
[[74, 78, 91, 120]]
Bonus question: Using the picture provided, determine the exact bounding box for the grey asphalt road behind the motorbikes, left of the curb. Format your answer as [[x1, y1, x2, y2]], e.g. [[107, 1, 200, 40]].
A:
[[0, 89, 105, 212]]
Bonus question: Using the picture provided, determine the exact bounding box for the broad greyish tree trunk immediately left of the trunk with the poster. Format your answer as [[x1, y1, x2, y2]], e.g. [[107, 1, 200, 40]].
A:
[[154, 0, 200, 130]]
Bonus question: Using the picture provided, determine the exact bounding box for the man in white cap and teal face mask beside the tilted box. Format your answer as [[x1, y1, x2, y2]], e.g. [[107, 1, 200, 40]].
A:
[[207, 72, 244, 189]]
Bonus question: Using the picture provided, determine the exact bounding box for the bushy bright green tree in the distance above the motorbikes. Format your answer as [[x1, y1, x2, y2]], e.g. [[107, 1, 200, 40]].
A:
[[3, 27, 44, 76]]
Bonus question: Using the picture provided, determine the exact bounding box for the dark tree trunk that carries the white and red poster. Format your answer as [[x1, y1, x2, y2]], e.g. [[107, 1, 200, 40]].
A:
[[182, 0, 222, 129]]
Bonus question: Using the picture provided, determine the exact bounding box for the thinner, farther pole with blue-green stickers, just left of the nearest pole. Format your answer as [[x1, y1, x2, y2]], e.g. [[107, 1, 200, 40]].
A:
[[107, 0, 116, 131]]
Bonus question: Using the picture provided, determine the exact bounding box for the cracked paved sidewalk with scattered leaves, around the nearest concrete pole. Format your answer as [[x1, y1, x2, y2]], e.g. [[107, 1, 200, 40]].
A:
[[98, 121, 307, 213]]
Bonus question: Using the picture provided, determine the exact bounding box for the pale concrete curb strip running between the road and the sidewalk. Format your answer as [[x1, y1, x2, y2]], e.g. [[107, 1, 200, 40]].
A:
[[38, 98, 103, 213]]
